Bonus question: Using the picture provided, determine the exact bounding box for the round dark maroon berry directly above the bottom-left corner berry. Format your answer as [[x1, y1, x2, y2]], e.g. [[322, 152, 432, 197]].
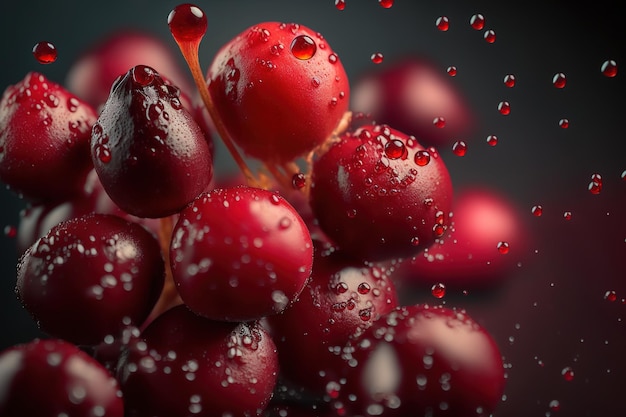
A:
[[16, 214, 164, 345]]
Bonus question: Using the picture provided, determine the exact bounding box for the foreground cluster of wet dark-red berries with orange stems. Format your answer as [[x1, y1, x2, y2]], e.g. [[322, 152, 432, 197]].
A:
[[0, 4, 528, 417]]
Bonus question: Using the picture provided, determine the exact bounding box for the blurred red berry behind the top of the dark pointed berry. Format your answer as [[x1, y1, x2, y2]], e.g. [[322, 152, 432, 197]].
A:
[[65, 29, 192, 108]]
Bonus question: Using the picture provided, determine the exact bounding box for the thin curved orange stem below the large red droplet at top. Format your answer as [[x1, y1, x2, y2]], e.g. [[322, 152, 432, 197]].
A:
[[176, 39, 260, 187]]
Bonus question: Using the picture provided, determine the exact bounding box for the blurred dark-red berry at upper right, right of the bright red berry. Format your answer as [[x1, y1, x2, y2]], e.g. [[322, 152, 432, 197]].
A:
[[352, 56, 477, 147]]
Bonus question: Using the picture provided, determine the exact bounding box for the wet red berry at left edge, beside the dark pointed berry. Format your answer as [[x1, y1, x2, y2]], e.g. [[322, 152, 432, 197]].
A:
[[0, 72, 97, 202]]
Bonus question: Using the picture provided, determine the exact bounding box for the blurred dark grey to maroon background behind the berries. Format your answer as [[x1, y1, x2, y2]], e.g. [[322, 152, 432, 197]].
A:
[[0, 0, 626, 417]]
